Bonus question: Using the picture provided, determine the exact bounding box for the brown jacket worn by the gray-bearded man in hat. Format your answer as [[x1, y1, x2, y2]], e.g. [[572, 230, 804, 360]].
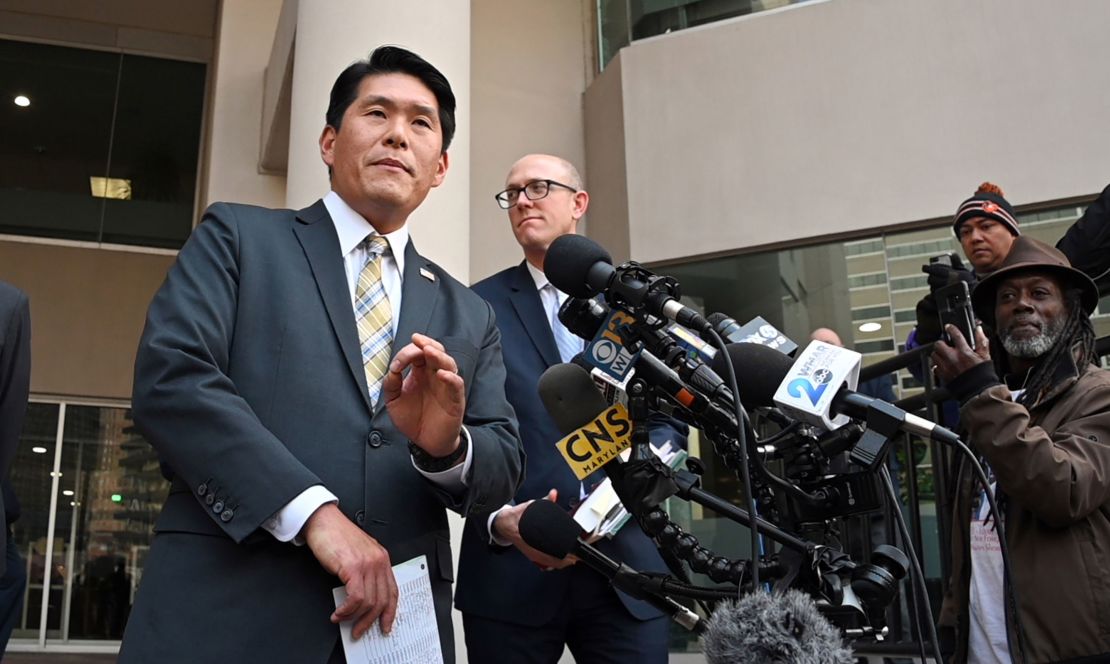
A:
[[939, 364, 1110, 664]]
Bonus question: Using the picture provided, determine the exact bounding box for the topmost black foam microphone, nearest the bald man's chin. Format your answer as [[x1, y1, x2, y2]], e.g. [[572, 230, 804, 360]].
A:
[[544, 234, 713, 334]]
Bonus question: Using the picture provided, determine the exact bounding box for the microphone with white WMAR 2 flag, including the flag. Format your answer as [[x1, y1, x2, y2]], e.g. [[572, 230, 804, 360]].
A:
[[726, 341, 959, 445]]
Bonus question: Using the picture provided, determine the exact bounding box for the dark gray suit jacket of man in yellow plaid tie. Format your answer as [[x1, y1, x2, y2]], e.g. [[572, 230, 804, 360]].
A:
[[120, 201, 524, 663]]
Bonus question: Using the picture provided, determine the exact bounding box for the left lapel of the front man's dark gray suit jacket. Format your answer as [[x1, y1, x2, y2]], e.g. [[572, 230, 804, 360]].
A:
[[293, 201, 372, 410]]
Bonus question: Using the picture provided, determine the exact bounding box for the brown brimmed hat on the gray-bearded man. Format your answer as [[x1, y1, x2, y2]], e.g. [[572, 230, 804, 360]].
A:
[[971, 235, 1099, 324]]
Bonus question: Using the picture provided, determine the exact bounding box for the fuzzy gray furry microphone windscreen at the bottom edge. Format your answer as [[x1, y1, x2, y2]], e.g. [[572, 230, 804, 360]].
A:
[[705, 590, 854, 664]]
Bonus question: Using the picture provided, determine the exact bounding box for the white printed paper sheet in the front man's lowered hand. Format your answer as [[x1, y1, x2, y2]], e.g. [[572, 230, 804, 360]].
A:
[[332, 555, 443, 664]]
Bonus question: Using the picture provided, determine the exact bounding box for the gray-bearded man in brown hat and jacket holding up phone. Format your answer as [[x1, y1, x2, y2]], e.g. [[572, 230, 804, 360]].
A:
[[932, 237, 1110, 663]]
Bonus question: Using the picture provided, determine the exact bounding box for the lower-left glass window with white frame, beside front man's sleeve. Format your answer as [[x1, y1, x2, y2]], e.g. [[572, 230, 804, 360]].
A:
[[12, 403, 169, 644]]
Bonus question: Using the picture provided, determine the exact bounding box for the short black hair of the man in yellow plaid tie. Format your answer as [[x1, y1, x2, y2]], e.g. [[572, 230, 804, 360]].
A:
[[324, 47, 455, 152]]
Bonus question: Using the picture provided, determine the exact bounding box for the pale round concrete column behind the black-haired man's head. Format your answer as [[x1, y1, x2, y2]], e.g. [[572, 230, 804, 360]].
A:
[[285, 0, 471, 283]]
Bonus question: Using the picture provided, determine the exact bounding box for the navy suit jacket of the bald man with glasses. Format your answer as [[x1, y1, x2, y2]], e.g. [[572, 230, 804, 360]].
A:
[[455, 262, 686, 625]]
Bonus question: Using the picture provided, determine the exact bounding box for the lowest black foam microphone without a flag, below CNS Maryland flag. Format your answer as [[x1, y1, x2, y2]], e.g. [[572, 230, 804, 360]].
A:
[[519, 501, 705, 633]]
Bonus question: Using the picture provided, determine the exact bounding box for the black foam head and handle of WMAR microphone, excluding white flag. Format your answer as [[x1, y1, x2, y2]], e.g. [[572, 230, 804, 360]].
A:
[[715, 343, 959, 445]]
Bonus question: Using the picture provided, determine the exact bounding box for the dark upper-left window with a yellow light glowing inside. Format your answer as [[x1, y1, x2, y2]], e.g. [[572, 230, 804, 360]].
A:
[[0, 40, 206, 249]]
